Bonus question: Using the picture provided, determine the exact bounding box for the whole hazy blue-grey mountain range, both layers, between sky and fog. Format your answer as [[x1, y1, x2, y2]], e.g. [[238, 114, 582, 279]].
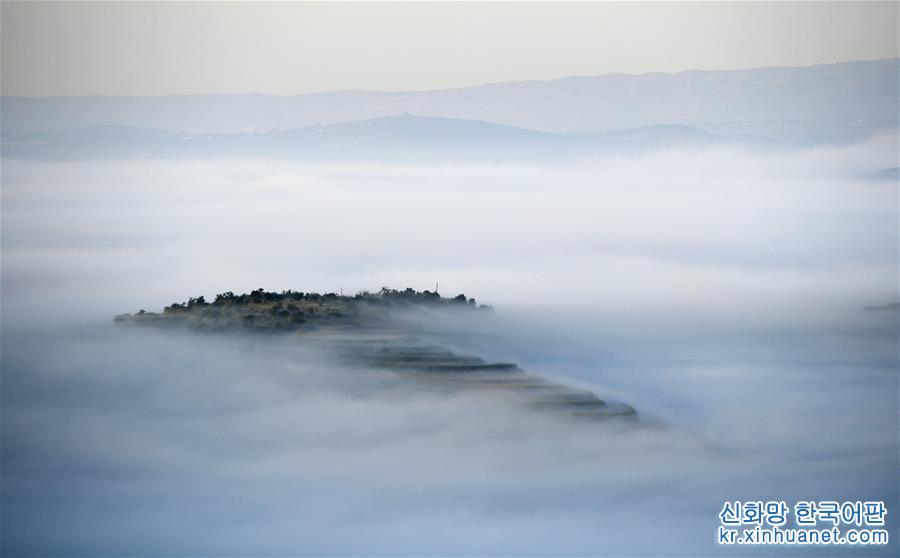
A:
[[0, 59, 900, 159]]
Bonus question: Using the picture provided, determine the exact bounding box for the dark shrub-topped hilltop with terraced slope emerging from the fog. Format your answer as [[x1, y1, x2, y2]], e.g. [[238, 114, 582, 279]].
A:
[[115, 288, 637, 420]]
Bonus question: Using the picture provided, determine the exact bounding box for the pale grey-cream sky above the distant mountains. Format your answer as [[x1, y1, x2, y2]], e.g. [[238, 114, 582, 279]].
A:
[[2, 0, 900, 96]]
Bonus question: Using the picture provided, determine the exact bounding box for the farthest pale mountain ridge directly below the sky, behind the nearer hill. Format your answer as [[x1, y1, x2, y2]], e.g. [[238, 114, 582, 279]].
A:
[[0, 58, 900, 135]]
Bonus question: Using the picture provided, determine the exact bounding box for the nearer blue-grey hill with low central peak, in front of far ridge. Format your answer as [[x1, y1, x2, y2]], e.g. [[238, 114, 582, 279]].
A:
[[2, 115, 721, 162]]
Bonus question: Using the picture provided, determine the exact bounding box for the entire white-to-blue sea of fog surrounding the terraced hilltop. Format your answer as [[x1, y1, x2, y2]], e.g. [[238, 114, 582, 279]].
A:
[[0, 137, 900, 556]]
